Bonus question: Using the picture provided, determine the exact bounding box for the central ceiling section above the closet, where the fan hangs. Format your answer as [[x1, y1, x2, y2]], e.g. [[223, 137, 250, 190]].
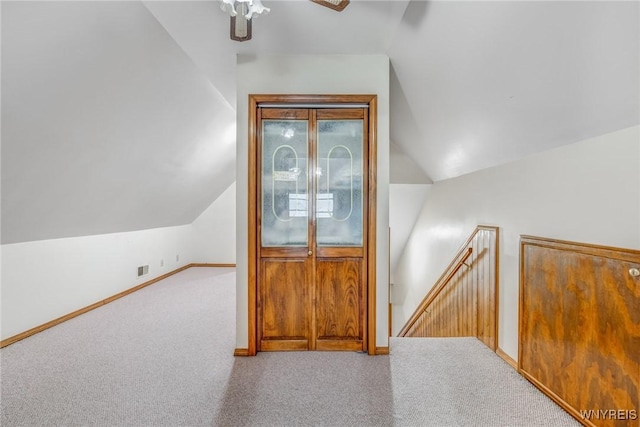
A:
[[144, 0, 409, 108]]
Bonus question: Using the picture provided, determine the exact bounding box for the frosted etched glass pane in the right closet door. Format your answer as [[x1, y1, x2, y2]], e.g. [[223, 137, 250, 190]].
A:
[[316, 120, 363, 246]]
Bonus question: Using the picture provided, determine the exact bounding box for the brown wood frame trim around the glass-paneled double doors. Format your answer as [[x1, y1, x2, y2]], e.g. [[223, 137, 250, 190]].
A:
[[247, 94, 378, 356]]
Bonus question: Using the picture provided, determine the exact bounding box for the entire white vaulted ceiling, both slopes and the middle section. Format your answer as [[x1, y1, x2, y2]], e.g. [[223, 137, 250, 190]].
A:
[[1, 0, 640, 243]]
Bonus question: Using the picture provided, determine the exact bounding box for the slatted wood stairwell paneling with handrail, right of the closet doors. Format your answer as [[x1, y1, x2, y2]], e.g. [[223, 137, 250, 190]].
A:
[[399, 226, 498, 351]]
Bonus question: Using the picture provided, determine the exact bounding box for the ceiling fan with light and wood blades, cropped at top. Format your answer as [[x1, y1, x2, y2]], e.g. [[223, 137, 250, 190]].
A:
[[220, 0, 349, 42]]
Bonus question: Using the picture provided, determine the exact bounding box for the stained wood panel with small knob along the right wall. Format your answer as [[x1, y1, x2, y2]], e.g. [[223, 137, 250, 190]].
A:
[[518, 236, 640, 427]]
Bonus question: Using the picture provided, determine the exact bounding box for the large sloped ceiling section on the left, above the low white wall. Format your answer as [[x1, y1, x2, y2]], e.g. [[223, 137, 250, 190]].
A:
[[2, 2, 235, 243]]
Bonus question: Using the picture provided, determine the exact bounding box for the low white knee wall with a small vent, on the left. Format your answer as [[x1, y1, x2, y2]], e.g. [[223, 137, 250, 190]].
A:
[[1, 225, 193, 339]]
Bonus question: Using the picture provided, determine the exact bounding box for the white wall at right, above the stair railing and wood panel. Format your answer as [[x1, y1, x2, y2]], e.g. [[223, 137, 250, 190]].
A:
[[393, 127, 640, 359]]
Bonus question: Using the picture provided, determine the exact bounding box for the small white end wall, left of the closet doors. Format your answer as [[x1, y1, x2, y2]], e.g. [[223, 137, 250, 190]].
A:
[[192, 182, 236, 264]]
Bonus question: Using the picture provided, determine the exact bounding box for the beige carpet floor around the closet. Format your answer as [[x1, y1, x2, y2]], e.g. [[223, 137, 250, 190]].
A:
[[0, 268, 578, 427]]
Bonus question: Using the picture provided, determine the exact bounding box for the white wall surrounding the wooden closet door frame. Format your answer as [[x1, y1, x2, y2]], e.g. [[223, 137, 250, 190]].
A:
[[236, 55, 389, 348]]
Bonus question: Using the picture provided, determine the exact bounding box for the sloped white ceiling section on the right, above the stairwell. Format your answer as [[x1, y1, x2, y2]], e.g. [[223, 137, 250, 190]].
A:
[[388, 1, 640, 181]]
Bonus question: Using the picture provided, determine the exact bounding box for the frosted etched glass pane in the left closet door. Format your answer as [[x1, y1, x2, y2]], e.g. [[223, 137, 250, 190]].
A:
[[262, 120, 309, 247]]
